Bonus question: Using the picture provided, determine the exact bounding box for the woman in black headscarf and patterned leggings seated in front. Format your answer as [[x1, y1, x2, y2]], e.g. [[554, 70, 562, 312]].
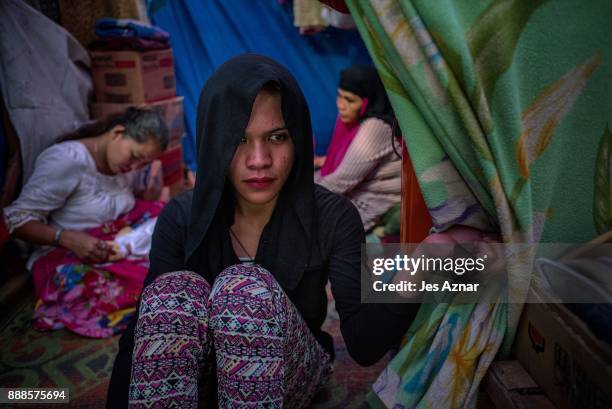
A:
[[107, 54, 418, 408]]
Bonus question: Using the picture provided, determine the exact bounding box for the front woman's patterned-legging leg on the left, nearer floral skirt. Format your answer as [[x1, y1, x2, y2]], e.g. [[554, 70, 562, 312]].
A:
[[130, 271, 210, 408]]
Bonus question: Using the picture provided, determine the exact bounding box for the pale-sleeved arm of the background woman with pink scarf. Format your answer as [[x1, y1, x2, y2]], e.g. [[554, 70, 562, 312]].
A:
[[315, 118, 393, 195]]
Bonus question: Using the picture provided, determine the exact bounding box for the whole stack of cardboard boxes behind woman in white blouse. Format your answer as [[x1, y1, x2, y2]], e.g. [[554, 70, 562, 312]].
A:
[[90, 49, 185, 195]]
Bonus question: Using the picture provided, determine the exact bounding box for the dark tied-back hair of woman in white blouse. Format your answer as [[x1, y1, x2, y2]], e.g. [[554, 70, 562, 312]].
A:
[[60, 107, 168, 150]]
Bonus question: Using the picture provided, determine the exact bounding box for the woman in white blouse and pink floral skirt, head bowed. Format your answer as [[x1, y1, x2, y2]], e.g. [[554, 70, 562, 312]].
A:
[[4, 108, 168, 337]]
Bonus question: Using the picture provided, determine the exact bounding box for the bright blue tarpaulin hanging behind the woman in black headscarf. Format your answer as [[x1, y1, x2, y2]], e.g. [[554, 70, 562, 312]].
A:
[[148, 0, 371, 169]]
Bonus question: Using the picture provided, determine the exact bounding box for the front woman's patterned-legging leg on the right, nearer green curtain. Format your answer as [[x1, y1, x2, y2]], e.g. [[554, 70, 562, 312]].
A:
[[209, 265, 331, 409]]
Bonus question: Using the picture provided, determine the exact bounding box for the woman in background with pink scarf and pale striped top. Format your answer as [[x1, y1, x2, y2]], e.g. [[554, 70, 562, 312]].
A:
[[315, 66, 401, 231]]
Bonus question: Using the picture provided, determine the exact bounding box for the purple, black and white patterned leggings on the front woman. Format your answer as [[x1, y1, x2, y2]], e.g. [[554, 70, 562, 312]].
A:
[[129, 265, 332, 408]]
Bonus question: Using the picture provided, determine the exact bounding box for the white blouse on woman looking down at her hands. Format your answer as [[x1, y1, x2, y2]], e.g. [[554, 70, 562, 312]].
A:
[[4, 141, 135, 265]]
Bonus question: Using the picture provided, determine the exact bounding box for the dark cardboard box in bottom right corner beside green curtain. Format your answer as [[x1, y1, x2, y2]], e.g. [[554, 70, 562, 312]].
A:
[[514, 288, 612, 409]]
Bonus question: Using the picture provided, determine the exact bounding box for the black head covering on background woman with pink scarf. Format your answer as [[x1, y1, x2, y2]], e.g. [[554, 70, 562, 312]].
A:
[[338, 65, 395, 126]]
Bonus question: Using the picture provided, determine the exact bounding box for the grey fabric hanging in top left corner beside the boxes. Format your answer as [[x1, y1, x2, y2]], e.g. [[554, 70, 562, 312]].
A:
[[0, 0, 93, 184]]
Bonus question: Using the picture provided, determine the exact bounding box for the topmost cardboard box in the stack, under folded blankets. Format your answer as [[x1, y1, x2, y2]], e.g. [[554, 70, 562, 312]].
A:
[[90, 49, 176, 104]]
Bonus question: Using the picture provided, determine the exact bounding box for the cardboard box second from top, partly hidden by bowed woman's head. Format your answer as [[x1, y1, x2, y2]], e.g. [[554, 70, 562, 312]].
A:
[[90, 97, 185, 149]]
